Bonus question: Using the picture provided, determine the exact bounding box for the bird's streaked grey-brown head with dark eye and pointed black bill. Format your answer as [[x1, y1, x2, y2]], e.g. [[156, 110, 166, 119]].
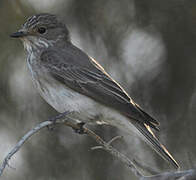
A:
[[11, 13, 70, 51]]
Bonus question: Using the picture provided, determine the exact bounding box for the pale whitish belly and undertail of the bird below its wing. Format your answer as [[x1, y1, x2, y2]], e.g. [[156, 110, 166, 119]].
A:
[[34, 69, 143, 138]]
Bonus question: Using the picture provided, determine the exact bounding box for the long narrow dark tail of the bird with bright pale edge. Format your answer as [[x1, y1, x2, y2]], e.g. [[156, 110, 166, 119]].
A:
[[132, 121, 179, 169]]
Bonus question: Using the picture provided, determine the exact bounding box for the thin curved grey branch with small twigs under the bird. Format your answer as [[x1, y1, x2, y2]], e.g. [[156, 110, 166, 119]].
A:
[[0, 113, 196, 180]]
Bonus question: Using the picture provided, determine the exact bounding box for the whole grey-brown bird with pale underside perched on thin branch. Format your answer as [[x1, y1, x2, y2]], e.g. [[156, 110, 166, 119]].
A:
[[10, 13, 179, 168]]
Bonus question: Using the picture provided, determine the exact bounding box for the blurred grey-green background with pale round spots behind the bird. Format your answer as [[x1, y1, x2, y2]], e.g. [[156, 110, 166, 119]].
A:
[[0, 0, 196, 180]]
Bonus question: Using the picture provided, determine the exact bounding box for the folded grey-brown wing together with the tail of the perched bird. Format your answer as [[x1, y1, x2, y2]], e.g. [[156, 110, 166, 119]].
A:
[[40, 49, 178, 167]]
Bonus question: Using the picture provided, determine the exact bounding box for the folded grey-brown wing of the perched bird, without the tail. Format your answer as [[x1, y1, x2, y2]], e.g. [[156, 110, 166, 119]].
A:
[[41, 47, 159, 130]]
